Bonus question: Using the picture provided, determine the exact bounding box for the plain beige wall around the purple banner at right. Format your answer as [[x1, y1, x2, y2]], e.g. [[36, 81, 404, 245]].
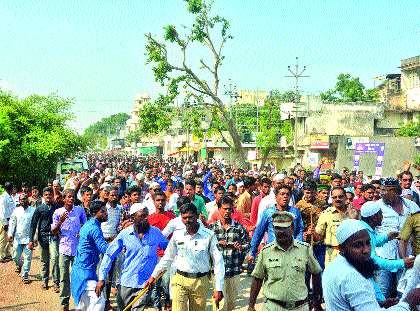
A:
[[336, 136, 420, 177]]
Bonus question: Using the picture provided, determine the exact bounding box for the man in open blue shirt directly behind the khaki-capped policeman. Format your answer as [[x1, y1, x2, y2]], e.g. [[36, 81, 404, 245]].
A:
[[249, 184, 304, 264]]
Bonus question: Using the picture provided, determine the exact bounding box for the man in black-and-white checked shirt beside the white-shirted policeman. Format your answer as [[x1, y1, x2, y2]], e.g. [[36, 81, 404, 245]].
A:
[[208, 196, 251, 311]]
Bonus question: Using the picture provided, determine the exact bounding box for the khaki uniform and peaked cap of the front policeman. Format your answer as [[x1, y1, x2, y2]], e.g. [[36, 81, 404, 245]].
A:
[[252, 212, 322, 311]]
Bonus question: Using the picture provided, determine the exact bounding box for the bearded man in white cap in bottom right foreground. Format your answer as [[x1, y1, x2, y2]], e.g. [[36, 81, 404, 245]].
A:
[[322, 219, 420, 311]]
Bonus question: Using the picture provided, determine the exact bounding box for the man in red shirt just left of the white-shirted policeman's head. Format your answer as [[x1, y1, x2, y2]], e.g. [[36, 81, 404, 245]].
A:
[[149, 191, 175, 310]]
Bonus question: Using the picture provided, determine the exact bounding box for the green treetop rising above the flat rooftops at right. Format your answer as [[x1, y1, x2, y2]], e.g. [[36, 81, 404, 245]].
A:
[[321, 73, 379, 102]]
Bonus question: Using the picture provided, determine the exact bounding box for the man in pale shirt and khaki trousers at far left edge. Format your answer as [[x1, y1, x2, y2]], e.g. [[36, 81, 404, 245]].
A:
[[0, 182, 16, 263]]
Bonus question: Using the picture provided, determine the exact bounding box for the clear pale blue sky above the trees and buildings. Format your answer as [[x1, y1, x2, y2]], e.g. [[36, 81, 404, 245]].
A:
[[0, 0, 420, 132]]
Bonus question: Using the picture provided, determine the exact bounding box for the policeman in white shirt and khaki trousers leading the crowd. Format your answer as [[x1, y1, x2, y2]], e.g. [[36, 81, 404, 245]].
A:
[[145, 203, 225, 311]]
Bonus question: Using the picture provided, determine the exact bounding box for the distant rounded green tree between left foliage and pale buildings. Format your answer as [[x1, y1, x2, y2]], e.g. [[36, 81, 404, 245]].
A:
[[84, 112, 130, 148]]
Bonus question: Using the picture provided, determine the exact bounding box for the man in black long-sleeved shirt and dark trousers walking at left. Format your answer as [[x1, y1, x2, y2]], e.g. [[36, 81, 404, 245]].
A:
[[28, 187, 60, 293]]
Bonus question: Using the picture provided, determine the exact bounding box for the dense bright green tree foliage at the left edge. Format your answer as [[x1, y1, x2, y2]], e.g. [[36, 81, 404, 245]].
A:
[[0, 89, 86, 186]]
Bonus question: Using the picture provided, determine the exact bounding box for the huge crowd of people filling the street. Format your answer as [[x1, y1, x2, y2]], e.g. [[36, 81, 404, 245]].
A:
[[0, 153, 420, 311]]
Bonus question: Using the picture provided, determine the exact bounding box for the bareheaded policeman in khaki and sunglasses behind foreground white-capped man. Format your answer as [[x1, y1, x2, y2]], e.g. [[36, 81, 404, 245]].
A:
[[308, 187, 358, 266]]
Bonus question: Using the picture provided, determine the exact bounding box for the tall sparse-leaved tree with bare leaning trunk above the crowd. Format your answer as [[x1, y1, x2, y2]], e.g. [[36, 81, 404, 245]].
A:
[[146, 0, 246, 167]]
